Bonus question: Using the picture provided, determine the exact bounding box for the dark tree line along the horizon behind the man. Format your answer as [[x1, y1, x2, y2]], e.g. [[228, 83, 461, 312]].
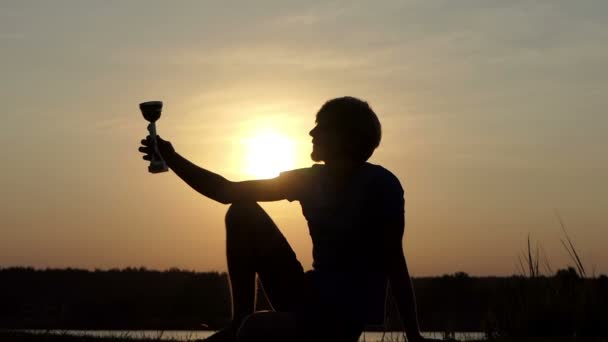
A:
[[0, 267, 608, 336]]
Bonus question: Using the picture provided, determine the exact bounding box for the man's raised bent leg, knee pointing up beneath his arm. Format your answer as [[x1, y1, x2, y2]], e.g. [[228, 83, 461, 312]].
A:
[[226, 202, 305, 323]]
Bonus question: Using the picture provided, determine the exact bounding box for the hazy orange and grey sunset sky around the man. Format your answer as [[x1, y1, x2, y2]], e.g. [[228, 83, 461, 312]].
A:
[[0, 0, 608, 276]]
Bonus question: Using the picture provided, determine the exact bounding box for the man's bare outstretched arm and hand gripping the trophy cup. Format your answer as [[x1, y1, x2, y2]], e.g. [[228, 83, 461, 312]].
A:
[[139, 137, 283, 204]]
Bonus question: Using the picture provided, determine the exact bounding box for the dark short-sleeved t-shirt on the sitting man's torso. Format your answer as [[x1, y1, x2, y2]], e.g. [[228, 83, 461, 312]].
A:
[[279, 163, 405, 324]]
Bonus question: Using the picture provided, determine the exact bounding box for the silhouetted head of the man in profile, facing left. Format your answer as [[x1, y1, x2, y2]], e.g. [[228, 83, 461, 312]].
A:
[[310, 96, 382, 163]]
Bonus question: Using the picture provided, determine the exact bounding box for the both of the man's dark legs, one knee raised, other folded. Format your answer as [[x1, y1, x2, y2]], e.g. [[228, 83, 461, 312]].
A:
[[220, 202, 360, 341]]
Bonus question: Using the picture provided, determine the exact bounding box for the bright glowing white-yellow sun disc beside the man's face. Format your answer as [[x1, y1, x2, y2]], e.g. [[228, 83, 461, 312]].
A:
[[244, 130, 296, 179]]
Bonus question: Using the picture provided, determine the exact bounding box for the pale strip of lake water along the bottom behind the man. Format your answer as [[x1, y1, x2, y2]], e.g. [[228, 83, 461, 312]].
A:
[[20, 330, 485, 342]]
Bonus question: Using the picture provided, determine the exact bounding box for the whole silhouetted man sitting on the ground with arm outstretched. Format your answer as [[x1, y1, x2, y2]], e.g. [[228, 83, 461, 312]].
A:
[[139, 97, 424, 342]]
